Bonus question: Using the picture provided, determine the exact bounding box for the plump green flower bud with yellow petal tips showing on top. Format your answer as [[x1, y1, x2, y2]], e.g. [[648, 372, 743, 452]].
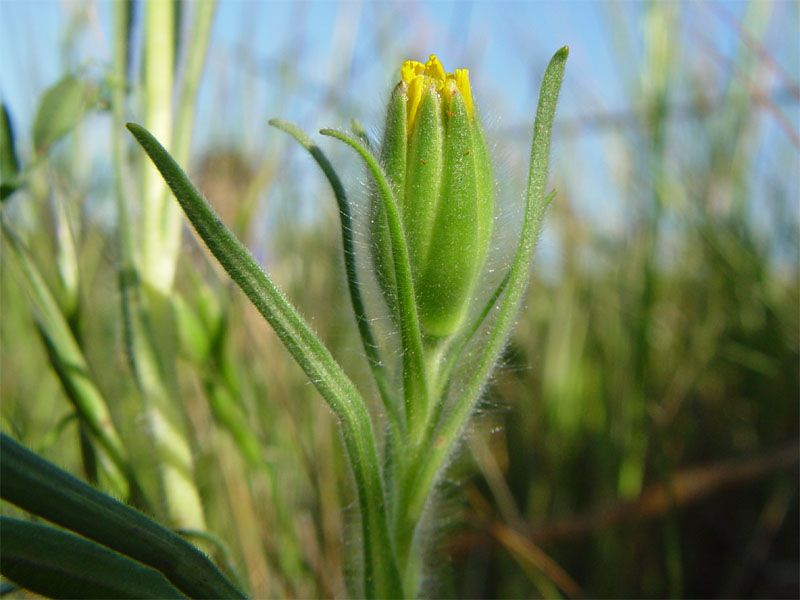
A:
[[372, 55, 494, 338]]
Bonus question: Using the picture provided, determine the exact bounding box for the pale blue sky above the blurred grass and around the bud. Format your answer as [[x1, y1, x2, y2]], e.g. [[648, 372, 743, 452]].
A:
[[0, 0, 800, 258]]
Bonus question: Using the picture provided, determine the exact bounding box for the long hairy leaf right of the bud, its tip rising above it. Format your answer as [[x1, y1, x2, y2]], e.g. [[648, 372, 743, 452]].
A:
[[399, 47, 569, 576]]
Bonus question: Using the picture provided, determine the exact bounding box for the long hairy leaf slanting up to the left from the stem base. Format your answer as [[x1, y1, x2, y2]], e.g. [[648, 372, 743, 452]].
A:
[[128, 123, 400, 597]]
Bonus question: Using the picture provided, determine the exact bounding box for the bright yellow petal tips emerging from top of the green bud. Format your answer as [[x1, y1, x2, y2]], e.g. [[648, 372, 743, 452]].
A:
[[400, 54, 473, 131]]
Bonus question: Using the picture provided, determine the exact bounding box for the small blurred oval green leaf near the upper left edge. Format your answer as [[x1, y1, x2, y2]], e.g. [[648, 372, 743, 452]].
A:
[[33, 75, 91, 154]]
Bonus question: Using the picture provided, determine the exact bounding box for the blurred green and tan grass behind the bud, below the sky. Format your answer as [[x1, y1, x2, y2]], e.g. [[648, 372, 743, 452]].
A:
[[0, 3, 800, 597]]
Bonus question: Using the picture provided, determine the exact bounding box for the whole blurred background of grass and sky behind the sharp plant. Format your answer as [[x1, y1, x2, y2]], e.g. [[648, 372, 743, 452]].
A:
[[0, 1, 800, 598]]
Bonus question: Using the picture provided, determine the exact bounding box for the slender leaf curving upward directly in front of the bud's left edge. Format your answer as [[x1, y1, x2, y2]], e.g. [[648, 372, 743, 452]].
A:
[[320, 129, 430, 441]]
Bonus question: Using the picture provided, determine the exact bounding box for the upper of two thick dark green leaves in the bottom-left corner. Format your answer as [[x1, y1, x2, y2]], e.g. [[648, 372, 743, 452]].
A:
[[0, 433, 244, 598]]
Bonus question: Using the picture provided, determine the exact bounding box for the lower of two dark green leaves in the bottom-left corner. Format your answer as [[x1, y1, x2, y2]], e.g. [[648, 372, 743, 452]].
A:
[[0, 517, 186, 598]]
